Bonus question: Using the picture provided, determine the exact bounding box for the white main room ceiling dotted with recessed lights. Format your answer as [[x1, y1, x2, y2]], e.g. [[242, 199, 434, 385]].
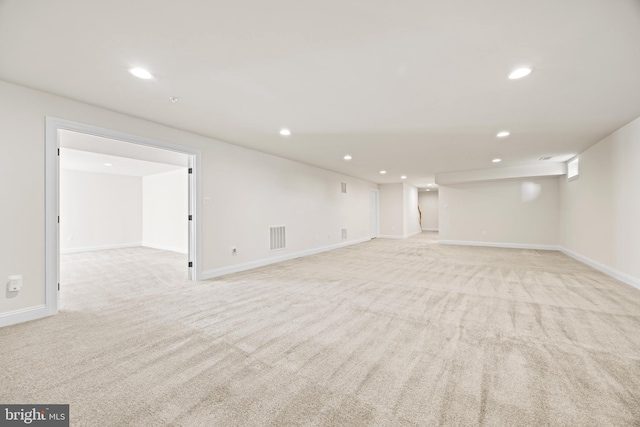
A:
[[0, 0, 640, 187]]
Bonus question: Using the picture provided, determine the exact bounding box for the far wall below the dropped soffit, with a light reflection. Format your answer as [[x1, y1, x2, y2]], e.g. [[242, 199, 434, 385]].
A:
[[439, 177, 560, 246]]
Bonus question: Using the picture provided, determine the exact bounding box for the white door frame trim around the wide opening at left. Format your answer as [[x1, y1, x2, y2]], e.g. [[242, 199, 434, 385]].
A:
[[45, 117, 202, 315]]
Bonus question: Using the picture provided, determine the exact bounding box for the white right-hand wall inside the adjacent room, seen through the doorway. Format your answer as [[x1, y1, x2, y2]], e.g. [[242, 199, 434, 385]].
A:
[[142, 168, 189, 254]]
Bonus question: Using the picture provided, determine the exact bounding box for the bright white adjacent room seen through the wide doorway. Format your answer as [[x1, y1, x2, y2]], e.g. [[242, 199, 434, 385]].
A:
[[58, 130, 190, 310]]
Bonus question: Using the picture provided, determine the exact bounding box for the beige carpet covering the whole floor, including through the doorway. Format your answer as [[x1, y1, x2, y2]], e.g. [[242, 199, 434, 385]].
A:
[[0, 233, 640, 426]]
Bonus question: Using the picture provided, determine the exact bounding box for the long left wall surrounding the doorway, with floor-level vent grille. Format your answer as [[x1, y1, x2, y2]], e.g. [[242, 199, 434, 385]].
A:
[[0, 81, 376, 316]]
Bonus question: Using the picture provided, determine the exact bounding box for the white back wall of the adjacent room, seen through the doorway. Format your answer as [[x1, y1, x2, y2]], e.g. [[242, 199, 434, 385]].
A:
[[60, 170, 142, 253]]
